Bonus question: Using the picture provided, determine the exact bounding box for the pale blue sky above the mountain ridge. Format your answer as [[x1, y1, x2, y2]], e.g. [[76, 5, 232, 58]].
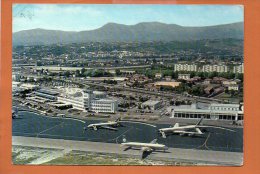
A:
[[13, 4, 244, 32]]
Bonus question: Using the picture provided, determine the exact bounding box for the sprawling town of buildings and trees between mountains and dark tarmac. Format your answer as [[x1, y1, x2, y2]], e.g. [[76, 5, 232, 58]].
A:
[[12, 43, 244, 124]]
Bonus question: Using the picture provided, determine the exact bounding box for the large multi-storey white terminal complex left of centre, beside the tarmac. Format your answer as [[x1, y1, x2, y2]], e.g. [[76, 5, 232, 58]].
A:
[[27, 88, 118, 113]]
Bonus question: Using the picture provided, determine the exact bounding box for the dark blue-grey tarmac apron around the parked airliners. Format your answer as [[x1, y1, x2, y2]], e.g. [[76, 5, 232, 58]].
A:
[[12, 112, 243, 152]]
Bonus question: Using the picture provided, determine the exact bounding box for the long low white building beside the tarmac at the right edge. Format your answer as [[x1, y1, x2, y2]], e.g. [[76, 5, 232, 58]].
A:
[[172, 103, 244, 121]]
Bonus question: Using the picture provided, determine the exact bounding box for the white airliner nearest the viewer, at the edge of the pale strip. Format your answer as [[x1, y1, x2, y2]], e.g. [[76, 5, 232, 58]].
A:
[[121, 139, 168, 158]]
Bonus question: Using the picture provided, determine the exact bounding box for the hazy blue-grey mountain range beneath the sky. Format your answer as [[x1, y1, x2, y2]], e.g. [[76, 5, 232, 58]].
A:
[[13, 22, 244, 46]]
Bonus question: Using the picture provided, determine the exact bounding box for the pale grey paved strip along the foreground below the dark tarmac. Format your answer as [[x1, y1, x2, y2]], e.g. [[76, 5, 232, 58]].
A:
[[12, 136, 243, 166]]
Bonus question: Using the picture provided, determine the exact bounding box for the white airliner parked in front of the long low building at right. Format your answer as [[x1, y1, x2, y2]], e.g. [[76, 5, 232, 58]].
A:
[[159, 117, 235, 138]]
